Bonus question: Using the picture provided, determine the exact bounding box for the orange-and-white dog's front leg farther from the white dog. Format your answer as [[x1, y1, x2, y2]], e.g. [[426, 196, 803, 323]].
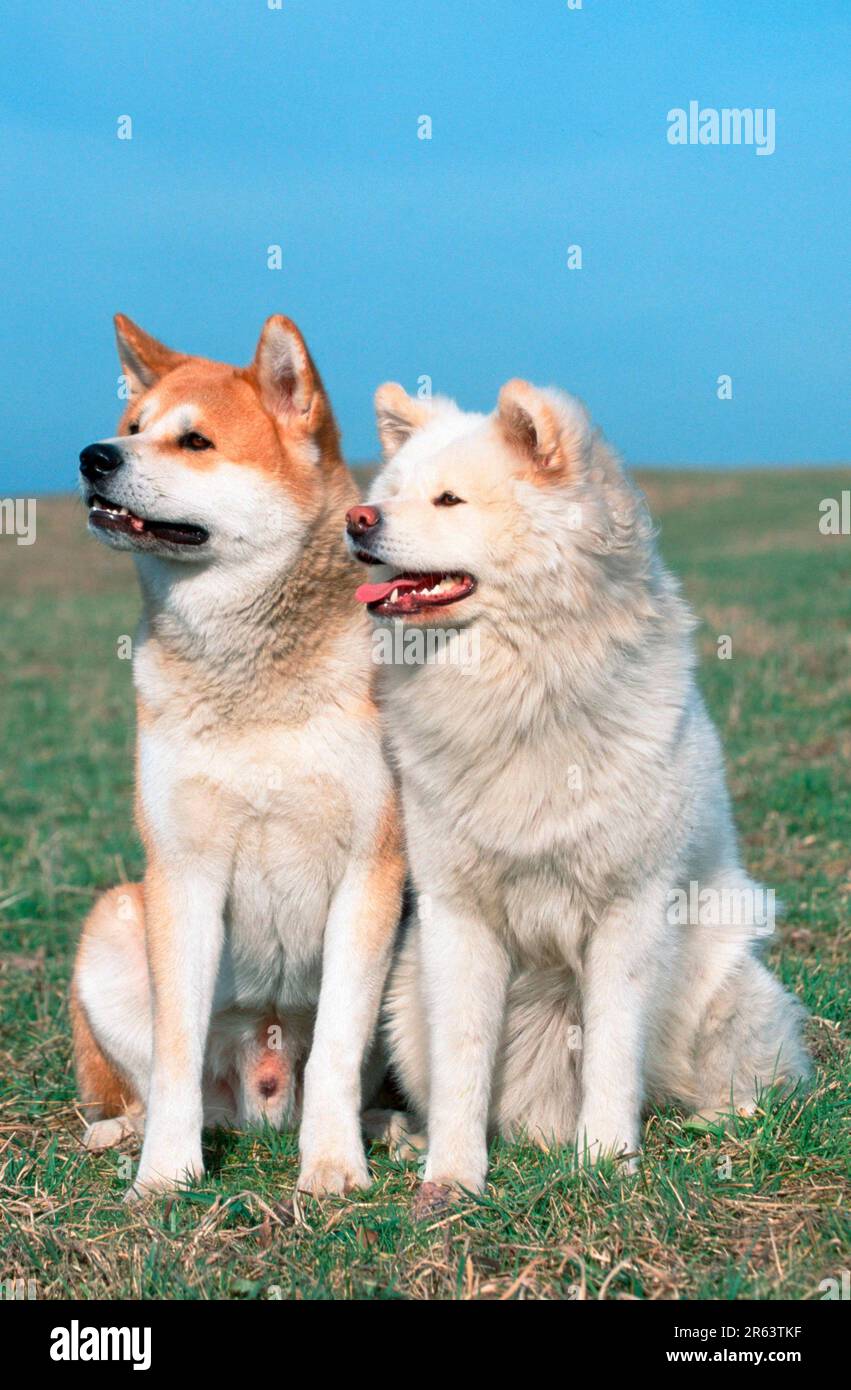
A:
[[129, 856, 225, 1195]]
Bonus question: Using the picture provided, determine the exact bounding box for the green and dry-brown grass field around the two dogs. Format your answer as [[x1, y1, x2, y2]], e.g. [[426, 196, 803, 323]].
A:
[[0, 470, 851, 1300]]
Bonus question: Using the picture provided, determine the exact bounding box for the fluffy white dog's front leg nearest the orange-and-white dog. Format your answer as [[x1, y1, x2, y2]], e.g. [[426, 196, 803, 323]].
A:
[[421, 899, 509, 1191]]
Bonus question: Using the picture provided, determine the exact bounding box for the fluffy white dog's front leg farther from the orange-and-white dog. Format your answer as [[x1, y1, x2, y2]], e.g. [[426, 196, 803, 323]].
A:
[[577, 888, 666, 1169]]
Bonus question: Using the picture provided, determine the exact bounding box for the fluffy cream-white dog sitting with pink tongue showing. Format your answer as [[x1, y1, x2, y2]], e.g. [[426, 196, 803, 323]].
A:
[[349, 381, 809, 1190]]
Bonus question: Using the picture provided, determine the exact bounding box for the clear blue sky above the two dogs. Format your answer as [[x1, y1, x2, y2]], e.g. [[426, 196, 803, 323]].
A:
[[0, 0, 851, 495]]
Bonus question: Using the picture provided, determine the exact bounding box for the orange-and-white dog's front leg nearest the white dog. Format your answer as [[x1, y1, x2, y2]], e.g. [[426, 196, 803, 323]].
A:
[[299, 820, 405, 1195]]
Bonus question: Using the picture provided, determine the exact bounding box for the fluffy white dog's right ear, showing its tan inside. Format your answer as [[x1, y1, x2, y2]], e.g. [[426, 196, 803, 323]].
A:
[[496, 379, 591, 482]]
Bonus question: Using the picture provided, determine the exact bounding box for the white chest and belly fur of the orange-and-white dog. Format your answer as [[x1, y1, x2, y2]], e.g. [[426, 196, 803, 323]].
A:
[[139, 695, 380, 1008]]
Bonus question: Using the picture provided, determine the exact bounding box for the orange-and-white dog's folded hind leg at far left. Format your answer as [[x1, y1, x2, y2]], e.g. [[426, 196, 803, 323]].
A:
[[71, 883, 152, 1152]]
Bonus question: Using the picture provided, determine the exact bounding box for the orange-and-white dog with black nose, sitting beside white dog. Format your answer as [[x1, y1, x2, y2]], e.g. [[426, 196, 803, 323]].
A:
[[72, 316, 403, 1194]]
